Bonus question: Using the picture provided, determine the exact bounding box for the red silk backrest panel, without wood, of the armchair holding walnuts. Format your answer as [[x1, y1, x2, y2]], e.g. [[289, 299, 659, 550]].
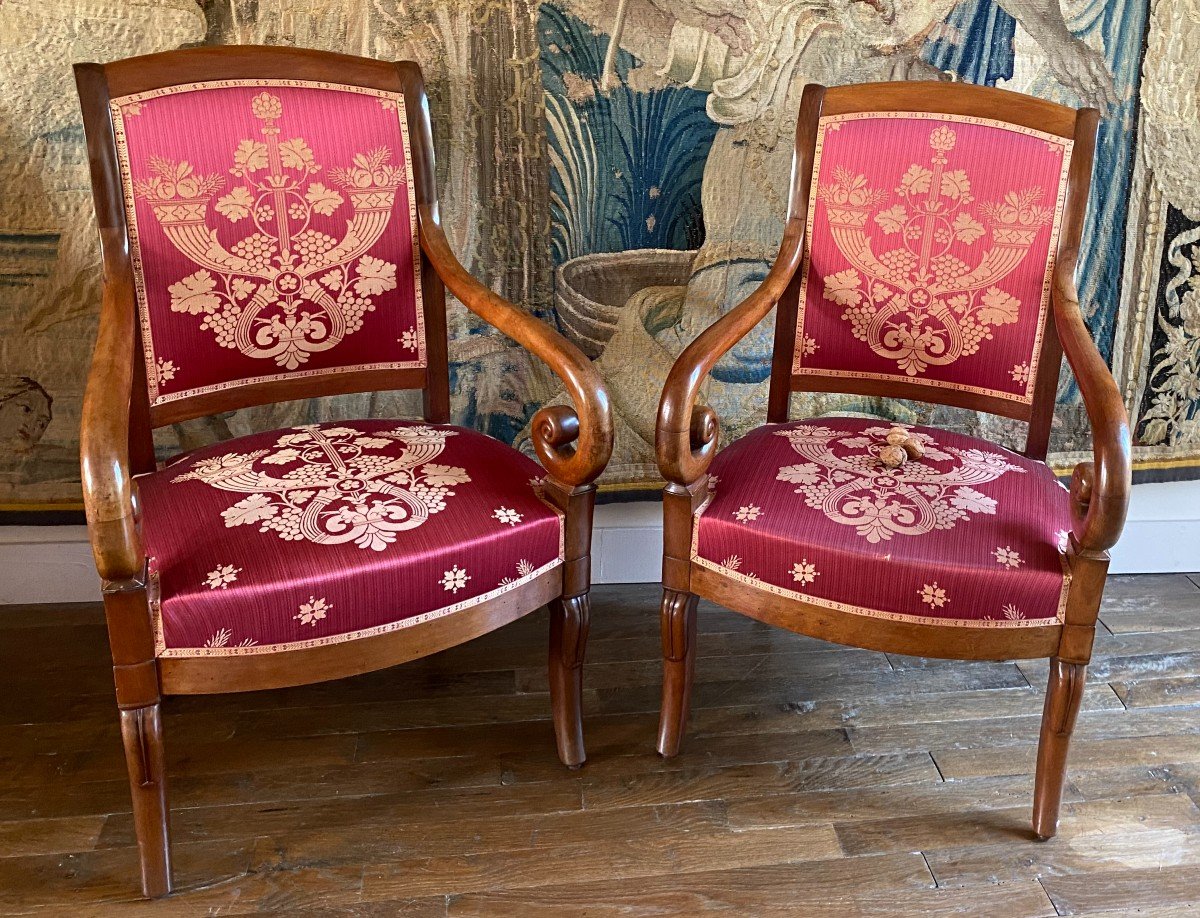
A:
[[792, 112, 1072, 404]]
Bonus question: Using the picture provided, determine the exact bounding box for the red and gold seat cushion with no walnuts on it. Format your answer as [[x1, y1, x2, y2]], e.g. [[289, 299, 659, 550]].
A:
[[138, 420, 563, 656]]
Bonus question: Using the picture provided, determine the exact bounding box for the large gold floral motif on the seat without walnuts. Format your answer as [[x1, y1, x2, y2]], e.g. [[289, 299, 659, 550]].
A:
[[173, 426, 470, 551]]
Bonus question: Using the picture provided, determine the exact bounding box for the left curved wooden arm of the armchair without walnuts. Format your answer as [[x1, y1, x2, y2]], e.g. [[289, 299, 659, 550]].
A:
[[79, 229, 145, 582]]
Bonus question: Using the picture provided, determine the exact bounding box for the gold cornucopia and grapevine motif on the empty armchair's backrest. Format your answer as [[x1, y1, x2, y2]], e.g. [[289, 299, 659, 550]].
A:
[[134, 91, 406, 370]]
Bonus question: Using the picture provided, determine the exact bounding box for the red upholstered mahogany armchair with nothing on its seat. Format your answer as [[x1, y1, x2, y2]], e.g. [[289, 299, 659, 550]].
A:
[[76, 47, 612, 896]]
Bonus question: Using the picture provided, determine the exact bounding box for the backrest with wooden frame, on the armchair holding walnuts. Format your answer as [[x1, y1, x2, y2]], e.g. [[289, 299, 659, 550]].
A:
[[773, 83, 1094, 456]]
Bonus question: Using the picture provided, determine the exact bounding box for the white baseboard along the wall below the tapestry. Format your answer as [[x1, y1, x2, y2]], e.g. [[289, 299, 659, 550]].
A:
[[0, 481, 1200, 604]]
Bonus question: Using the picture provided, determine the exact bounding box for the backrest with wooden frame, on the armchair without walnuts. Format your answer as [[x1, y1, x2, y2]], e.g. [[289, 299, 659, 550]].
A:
[[79, 48, 446, 436]]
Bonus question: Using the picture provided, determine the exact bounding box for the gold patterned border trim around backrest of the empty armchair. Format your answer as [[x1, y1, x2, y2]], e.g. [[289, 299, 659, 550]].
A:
[[108, 79, 428, 408]]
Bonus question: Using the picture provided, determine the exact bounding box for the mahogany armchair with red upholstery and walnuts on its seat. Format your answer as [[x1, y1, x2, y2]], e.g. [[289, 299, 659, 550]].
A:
[[656, 83, 1130, 839]]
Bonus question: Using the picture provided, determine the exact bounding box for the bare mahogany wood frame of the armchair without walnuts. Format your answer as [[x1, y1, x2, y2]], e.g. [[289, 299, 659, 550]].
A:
[[76, 46, 613, 898]]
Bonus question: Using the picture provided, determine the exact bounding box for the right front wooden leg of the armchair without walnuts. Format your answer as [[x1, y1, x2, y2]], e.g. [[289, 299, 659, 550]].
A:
[[550, 593, 592, 768]]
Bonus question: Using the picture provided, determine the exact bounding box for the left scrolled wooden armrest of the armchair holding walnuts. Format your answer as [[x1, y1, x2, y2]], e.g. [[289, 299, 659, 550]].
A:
[[654, 220, 804, 486]]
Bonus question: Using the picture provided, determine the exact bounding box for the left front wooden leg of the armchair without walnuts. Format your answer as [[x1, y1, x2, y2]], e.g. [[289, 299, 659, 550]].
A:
[[121, 703, 172, 899]]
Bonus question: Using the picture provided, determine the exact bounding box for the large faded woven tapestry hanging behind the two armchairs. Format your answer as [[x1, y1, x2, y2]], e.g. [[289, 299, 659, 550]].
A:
[[0, 0, 1200, 521]]
